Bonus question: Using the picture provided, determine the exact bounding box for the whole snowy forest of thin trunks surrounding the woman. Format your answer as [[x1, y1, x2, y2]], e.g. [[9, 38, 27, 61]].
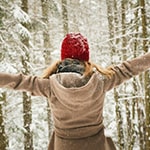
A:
[[0, 0, 150, 150]]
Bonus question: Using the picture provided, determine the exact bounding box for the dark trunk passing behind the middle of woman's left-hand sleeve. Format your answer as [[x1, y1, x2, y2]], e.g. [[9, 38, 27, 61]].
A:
[[21, 0, 33, 150]]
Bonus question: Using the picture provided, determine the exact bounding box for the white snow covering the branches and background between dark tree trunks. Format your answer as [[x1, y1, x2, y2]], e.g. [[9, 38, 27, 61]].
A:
[[0, 0, 150, 150]]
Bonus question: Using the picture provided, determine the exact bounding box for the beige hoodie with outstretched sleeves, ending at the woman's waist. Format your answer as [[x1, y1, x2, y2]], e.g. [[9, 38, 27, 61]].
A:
[[0, 53, 150, 147]]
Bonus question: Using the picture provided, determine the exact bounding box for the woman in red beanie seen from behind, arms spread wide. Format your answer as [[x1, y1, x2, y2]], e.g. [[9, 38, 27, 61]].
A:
[[0, 33, 150, 150]]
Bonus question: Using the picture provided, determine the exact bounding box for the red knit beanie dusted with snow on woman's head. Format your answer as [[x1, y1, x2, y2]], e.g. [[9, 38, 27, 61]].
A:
[[61, 33, 89, 61]]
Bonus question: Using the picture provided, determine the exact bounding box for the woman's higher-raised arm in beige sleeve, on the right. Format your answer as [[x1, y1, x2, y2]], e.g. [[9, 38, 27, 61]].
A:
[[104, 53, 150, 91]]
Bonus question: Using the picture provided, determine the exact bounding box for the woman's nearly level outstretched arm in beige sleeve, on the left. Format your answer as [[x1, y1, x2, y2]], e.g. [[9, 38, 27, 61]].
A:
[[0, 73, 50, 97]]
